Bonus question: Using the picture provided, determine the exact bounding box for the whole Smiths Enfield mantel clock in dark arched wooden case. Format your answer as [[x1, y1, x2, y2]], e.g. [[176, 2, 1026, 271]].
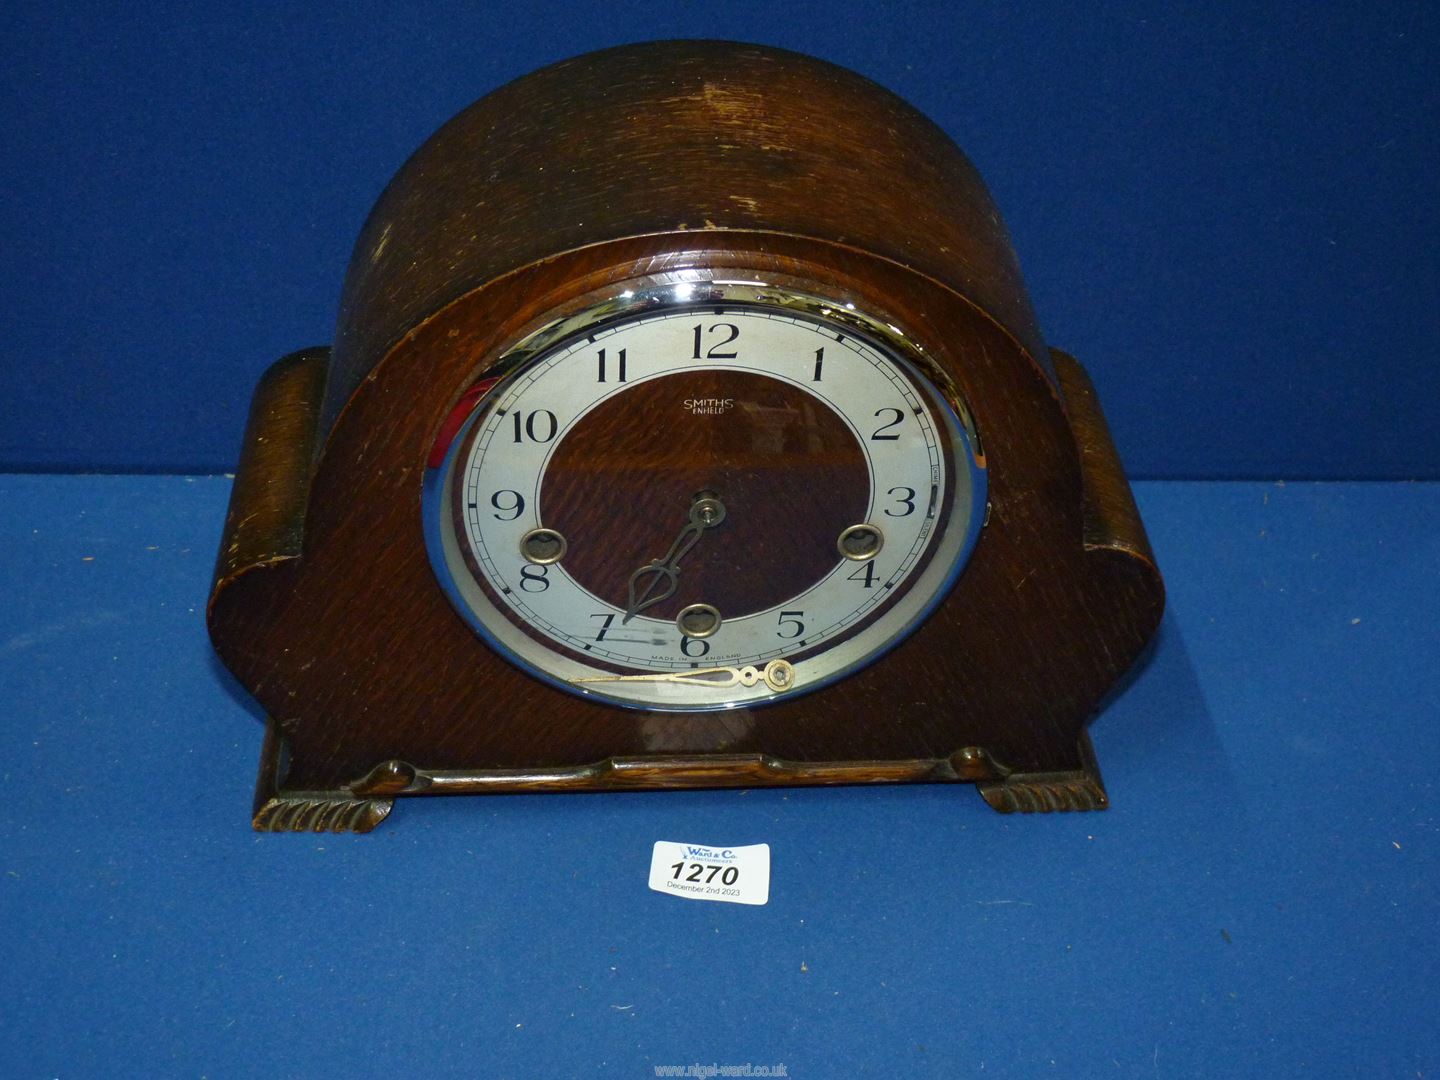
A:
[[209, 42, 1164, 831]]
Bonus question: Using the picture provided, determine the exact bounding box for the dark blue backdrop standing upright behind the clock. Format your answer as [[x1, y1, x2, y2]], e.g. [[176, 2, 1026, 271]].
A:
[[0, 0, 1440, 477]]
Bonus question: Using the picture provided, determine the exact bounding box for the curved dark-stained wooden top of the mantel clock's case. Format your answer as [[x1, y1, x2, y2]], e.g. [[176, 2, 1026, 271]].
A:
[[324, 42, 1050, 440]]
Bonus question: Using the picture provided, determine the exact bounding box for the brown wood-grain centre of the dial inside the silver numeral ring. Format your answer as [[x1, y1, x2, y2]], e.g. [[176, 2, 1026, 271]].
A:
[[529, 372, 870, 619]]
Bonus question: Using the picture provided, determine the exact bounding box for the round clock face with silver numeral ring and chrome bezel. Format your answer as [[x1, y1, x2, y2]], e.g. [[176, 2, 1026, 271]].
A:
[[426, 284, 985, 710]]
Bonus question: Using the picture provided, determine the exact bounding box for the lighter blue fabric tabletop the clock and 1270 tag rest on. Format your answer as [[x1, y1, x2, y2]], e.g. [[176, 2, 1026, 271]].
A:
[[0, 475, 1440, 1080]]
